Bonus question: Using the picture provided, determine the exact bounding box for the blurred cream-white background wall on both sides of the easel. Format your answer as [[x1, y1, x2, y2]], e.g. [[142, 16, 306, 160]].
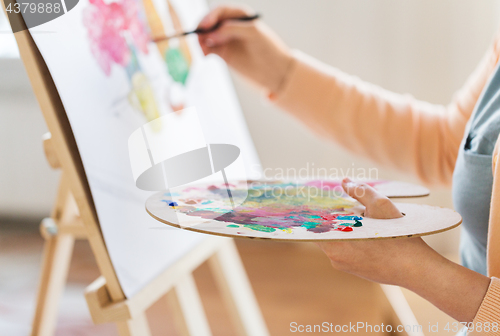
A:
[[0, 0, 500, 251]]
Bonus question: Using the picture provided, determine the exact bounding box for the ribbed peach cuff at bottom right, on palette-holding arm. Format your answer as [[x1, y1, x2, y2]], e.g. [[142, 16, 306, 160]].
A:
[[467, 277, 500, 336]]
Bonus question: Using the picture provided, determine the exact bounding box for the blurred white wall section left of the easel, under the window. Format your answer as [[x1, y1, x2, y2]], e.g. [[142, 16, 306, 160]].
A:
[[0, 58, 58, 218]]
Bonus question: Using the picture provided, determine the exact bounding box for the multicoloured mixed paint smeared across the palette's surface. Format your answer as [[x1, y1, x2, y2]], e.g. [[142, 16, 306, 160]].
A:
[[169, 181, 363, 233]]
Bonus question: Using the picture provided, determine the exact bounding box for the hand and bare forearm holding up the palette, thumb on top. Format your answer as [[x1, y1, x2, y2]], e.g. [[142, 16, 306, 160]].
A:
[[318, 179, 490, 322]]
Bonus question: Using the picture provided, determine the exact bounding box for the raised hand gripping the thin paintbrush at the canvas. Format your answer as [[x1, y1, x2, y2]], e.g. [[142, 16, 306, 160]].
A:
[[198, 6, 292, 93]]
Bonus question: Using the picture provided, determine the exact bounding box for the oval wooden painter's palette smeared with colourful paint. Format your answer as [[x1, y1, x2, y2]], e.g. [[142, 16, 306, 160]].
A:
[[146, 181, 461, 240]]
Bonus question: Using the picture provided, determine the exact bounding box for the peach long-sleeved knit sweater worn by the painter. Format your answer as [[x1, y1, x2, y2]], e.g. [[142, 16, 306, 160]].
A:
[[270, 35, 500, 335]]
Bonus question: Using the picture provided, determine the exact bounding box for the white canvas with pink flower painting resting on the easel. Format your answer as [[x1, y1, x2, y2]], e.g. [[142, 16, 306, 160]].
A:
[[23, 0, 260, 297]]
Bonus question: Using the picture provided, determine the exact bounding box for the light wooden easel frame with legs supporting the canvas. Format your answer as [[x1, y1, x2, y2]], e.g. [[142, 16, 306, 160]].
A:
[[4, 7, 268, 336]]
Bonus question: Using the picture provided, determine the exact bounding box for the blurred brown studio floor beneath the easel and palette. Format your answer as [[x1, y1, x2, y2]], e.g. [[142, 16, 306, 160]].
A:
[[0, 226, 453, 336]]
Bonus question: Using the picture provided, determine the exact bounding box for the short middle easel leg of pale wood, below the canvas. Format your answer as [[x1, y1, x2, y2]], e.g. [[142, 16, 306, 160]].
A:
[[166, 274, 212, 336]]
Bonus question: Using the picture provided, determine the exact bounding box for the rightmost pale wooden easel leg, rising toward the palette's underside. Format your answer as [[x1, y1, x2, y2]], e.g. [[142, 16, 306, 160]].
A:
[[209, 240, 269, 336]]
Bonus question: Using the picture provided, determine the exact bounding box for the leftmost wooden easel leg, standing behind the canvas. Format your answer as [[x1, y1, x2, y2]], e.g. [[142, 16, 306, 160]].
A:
[[31, 234, 75, 336]]
